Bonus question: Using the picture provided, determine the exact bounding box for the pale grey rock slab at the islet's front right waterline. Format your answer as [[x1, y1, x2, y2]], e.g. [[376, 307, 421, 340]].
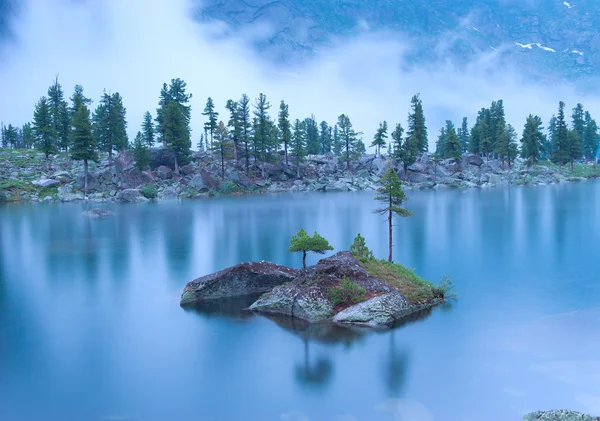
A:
[[333, 291, 415, 327]]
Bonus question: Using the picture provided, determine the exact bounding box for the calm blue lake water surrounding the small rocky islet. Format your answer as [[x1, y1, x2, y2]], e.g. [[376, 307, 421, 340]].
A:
[[0, 182, 600, 421]]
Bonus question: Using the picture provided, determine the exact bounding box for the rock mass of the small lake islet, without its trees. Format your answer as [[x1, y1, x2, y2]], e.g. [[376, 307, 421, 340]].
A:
[[181, 251, 444, 327]]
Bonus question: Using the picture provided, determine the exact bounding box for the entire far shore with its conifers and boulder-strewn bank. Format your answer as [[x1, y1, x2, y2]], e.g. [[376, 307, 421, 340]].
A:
[[0, 78, 600, 202]]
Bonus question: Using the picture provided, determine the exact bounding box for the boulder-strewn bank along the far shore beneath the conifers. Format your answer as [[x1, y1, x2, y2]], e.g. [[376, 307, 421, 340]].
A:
[[0, 148, 600, 203]]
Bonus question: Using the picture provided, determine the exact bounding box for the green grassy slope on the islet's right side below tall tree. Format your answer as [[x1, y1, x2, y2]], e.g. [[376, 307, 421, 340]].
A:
[[359, 259, 452, 304]]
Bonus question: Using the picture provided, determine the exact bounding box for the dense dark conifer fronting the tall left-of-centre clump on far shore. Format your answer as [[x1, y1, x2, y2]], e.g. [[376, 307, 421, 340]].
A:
[[161, 101, 192, 174]]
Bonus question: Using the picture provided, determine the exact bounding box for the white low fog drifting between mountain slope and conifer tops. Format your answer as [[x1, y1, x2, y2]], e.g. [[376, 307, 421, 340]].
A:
[[0, 0, 600, 146]]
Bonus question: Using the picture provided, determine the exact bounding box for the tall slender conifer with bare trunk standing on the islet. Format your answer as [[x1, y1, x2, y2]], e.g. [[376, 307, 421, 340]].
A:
[[375, 168, 418, 262]]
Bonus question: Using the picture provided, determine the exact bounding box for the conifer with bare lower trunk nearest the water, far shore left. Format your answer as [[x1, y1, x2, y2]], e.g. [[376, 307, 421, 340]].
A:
[[71, 102, 98, 194]]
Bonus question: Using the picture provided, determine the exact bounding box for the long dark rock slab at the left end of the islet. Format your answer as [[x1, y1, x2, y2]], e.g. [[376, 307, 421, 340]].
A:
[[181, 261, 298, 304]]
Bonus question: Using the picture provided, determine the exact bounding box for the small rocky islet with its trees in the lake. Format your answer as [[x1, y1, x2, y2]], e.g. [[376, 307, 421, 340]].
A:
[[181, 169, 452, 328]]
